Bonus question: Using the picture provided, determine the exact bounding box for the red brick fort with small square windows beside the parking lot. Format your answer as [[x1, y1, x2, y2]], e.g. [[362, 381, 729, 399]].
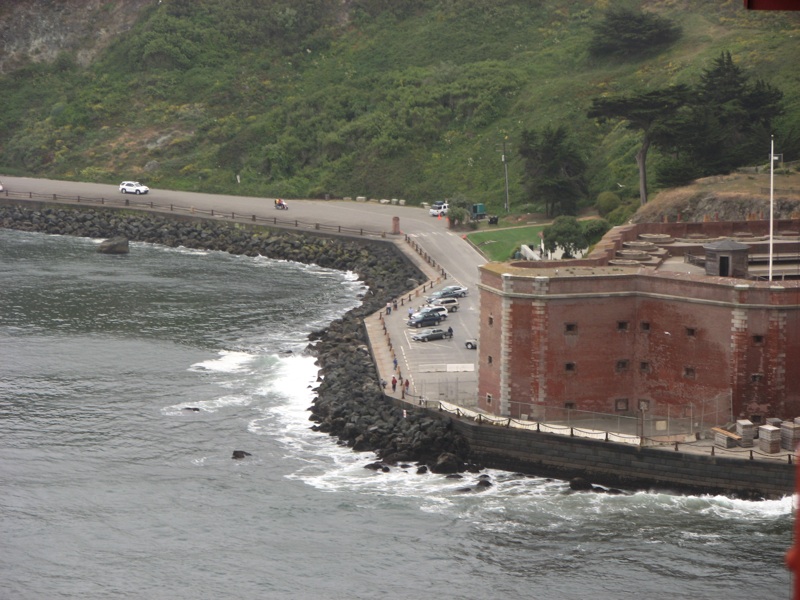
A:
[[478, 220, 800, 424]]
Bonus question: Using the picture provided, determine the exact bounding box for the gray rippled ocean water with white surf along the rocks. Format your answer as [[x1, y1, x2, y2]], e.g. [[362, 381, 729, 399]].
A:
[[0, 229, 793, 600]]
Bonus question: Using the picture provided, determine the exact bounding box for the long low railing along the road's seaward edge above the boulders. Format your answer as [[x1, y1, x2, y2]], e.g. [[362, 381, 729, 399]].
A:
[[2, 190, 388, 238]]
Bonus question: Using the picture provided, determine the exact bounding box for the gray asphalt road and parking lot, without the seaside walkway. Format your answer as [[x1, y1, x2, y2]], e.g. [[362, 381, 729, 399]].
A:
[[2, 177, 486, 406]]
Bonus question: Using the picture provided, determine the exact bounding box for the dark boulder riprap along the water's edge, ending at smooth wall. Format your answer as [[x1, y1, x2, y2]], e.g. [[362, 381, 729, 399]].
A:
[[0, 205, 478, 473]]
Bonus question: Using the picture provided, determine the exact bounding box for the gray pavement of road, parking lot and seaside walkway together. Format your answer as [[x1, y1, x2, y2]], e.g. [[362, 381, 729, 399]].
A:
[[2, 177, 486, 407]]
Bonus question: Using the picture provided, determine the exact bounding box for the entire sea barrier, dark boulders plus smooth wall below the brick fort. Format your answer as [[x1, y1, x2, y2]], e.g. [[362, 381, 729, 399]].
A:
[[0, 199, 795, 498]]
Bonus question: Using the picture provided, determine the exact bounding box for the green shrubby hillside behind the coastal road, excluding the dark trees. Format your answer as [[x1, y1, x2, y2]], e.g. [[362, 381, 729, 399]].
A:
[[0, 0, 800, 212]]
